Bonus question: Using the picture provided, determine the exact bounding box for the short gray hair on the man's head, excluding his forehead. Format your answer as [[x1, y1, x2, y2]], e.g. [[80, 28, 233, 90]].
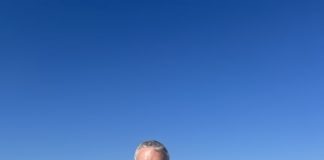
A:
[[134, 140, 170, 160]]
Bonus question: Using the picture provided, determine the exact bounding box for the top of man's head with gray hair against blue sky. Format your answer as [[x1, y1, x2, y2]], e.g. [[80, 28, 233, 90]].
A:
[[134, 140, 170, 160]]
